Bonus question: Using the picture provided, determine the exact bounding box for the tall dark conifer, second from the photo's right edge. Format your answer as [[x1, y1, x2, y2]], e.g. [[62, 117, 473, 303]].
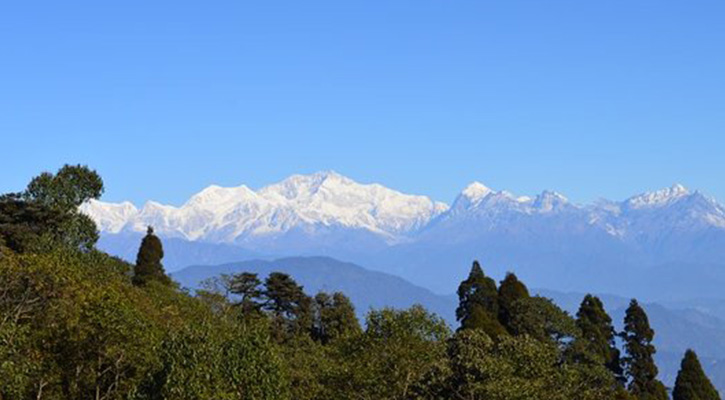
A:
[[622, 299, 669, 400]]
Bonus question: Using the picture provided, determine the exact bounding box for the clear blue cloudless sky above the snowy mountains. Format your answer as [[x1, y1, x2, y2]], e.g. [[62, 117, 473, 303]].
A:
[[0, 0, 725, 205]]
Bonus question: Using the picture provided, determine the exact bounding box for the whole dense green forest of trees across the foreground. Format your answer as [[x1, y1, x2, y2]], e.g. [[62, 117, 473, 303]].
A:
[[0, 165, 720, 400]]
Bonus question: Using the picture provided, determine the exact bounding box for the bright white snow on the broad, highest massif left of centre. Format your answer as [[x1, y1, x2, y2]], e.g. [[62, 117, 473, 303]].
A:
[[81, 172, 448, 243]]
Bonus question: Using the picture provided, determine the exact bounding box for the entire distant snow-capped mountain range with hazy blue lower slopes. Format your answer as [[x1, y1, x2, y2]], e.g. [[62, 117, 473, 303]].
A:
[[81, 172, 725, 301]]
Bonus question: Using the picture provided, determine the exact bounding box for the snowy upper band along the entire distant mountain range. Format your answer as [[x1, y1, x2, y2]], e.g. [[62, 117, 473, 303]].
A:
[[82, 171, 725, 255]]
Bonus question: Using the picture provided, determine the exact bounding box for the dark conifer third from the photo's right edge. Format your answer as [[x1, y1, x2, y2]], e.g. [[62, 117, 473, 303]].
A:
[[576, 294, 624, 382]]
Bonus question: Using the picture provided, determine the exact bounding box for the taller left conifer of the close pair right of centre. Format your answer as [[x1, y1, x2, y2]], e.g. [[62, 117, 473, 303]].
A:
[[456, 261, 506, 338]]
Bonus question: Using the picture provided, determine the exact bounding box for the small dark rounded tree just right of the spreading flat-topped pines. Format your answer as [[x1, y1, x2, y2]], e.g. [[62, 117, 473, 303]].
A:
[[312, 292, 362, 344]]
